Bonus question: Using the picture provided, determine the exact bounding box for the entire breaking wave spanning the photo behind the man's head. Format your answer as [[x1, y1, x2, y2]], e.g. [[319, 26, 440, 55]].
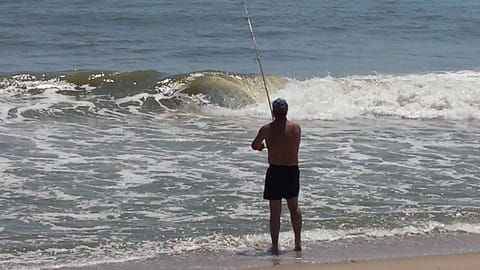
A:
[[0, 70, 480, 121]]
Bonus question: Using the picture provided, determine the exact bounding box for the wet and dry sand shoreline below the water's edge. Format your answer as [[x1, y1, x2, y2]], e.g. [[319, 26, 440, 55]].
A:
[[49, 233, 480, 270]]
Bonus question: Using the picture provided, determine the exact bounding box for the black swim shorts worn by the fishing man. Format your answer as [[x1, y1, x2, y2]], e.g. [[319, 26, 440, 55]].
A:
[[263, 165, 300, 200]]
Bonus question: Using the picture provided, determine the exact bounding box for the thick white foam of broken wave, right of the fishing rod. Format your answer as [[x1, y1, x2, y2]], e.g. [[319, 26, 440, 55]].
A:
[[209, 71, 480, 120]]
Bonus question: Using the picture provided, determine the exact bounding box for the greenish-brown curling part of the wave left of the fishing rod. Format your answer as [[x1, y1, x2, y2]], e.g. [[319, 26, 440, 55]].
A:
[[0, 70, 286, 120]]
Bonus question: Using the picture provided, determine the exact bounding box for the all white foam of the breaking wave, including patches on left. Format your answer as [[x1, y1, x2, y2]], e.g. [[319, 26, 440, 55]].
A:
[[0, 71, 480, 121]]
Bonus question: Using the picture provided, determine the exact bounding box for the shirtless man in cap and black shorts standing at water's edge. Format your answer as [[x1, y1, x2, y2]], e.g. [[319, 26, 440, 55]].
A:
[[252, 98, 302, 254]]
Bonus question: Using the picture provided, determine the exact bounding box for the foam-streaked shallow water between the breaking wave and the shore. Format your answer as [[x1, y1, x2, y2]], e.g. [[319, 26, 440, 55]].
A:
[[1, 111, 480, 266]]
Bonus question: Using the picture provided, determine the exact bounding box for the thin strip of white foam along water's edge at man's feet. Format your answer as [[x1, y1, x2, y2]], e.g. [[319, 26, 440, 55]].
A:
[[37, 222, 480, 262]]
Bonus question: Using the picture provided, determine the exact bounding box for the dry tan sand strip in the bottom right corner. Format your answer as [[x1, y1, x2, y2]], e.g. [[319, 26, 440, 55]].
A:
[[249, 253, 480, 270]]
